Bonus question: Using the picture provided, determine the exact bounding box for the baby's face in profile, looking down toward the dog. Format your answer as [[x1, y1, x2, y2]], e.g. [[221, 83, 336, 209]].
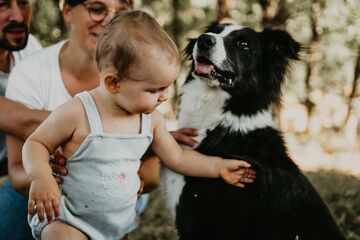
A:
[[117, 50, 179, 113]]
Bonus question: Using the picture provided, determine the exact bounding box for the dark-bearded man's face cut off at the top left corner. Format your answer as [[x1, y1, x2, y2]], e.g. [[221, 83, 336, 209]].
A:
[[0, 0, 31, 51]]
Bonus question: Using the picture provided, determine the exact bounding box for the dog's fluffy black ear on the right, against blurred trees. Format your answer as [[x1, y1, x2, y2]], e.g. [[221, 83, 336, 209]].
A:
[[261, 28, 301, 64]]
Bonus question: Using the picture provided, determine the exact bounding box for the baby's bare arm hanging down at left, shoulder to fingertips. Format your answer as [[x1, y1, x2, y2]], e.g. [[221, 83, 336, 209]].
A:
[[23, 99, 82, 222]]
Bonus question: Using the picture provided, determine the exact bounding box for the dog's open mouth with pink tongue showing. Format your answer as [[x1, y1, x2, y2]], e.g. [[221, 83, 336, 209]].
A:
[[194, 56, 235, 86]]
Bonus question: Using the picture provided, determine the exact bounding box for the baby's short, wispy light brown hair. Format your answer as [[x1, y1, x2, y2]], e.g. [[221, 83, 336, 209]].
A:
[[95, 10, 180, 77]]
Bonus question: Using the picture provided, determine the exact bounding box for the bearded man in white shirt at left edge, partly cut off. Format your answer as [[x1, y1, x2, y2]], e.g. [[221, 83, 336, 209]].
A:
[[0, 0, 43, 176]]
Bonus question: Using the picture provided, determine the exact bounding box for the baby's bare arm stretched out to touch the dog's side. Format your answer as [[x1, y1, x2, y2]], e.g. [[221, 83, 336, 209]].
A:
[[152, 111, 255, 187]]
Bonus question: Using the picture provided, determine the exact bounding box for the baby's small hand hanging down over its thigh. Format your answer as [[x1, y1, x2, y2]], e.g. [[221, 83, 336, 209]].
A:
[[28, 176, 60, 222]]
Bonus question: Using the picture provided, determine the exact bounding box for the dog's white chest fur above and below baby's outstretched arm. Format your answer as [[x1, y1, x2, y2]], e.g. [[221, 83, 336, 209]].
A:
[[161, 79, 229, 217]]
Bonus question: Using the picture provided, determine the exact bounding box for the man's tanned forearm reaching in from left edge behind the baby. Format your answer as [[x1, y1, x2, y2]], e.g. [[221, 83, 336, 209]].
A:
[[0, 96, 50, 140]]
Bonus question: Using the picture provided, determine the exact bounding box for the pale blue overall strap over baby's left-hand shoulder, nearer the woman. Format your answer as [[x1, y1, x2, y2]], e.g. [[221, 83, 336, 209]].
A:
[[76, 91, 103, 133]]
